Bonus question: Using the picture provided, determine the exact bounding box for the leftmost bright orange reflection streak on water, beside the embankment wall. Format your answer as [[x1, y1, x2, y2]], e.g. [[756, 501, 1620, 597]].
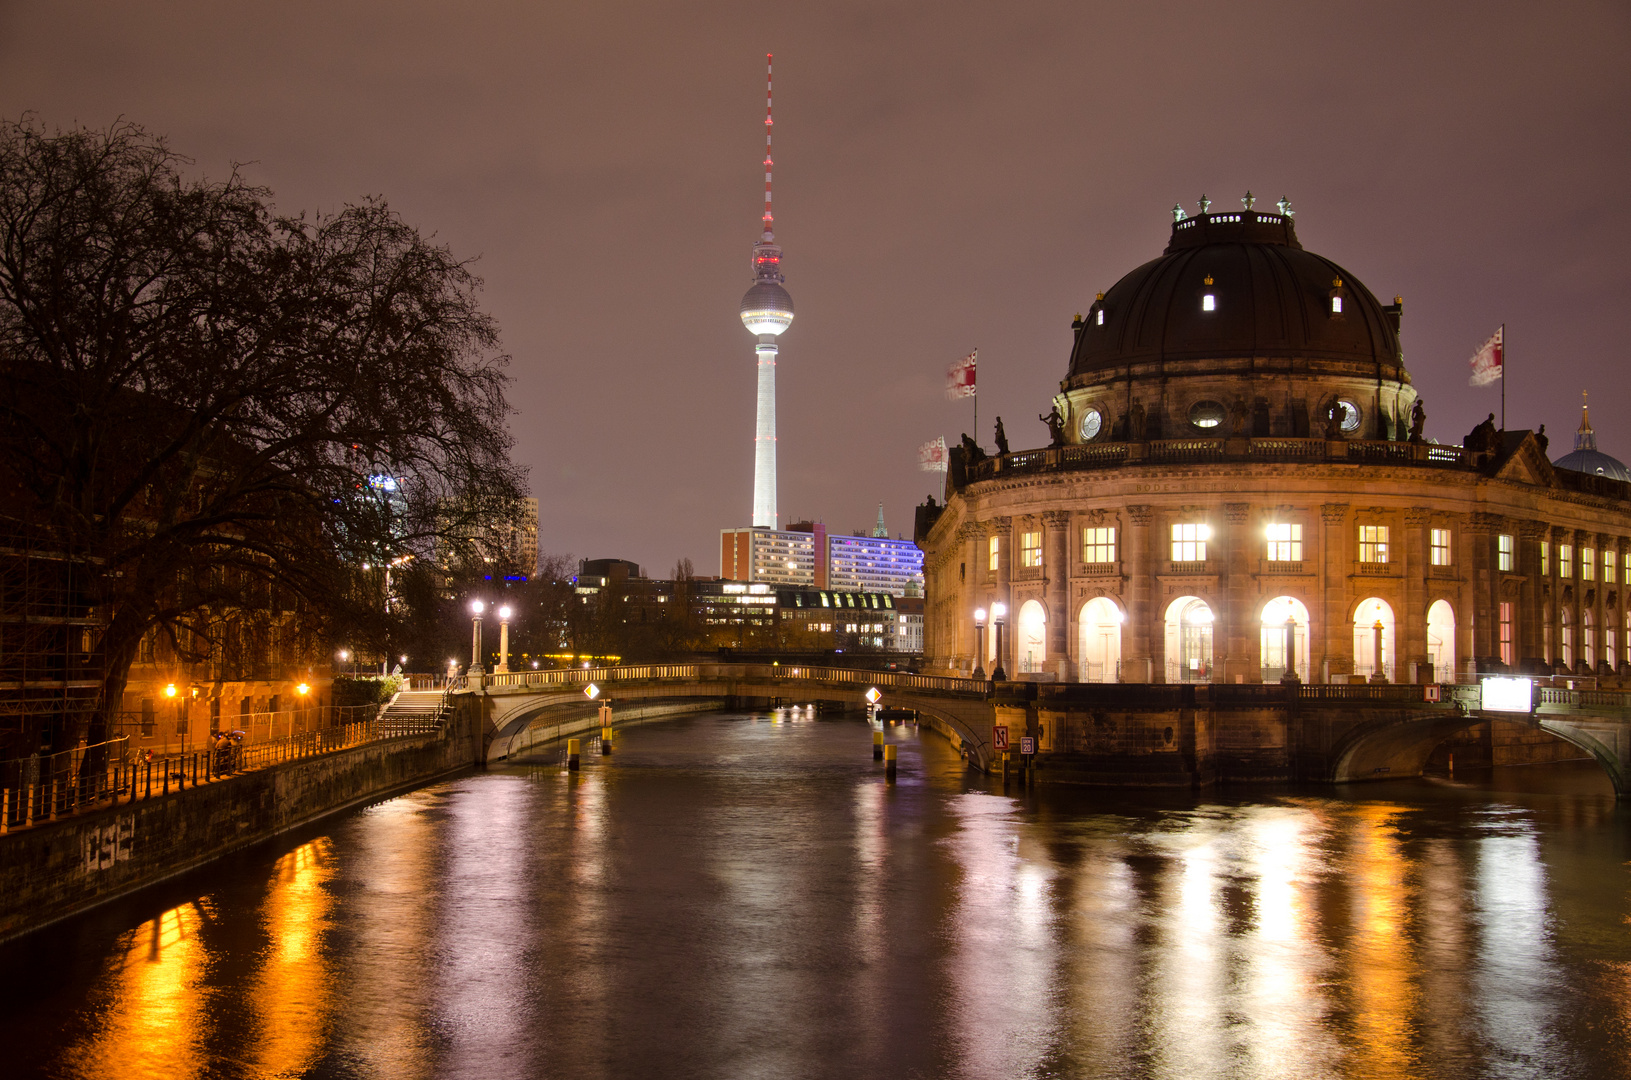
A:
[[62, 904, 207, 1080]]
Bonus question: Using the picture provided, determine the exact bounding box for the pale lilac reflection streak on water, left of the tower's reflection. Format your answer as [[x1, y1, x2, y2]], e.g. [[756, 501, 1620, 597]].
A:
[[434, 777, 533, 1077]]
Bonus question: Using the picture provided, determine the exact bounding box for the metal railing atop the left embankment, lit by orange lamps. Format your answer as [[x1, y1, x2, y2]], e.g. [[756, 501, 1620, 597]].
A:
[[0, 705, 442, 832]]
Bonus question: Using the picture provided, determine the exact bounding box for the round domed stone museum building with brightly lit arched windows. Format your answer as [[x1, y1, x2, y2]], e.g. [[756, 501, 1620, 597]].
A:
[[918, 197, 1631, 684]]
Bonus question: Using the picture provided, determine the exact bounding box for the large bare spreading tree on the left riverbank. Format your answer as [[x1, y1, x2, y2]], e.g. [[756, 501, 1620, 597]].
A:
[[0, 121, 524, 753]]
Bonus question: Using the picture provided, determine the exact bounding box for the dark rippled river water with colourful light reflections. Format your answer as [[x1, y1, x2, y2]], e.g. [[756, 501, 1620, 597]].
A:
[[0, 711, 1631, 1080]]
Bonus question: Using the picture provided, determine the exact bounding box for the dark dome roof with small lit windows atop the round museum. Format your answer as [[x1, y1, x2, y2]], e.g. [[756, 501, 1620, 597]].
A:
[[1065, 203, 1409, 387]]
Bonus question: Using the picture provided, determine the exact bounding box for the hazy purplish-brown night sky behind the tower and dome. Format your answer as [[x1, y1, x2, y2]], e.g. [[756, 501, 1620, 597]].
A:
[[0, 0, 1631, 574]]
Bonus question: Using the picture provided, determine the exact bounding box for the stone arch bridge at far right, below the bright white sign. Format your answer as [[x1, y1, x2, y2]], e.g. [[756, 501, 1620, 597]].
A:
[[1331, 710, 1631, 796]]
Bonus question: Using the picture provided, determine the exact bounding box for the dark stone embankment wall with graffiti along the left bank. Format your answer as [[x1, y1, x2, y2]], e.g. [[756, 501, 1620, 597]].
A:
[[0, 719, 478, 941]]
